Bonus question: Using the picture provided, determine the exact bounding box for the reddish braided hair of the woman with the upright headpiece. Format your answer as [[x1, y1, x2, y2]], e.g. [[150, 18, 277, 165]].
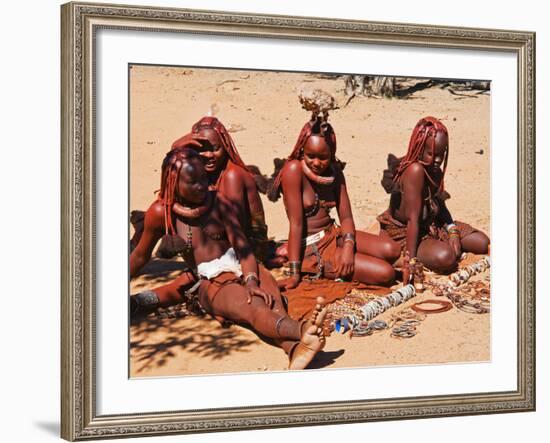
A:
[[267, 115, 340, 202]]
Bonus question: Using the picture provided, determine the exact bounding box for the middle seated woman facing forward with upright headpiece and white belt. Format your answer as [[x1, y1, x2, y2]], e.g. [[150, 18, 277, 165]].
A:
[[268, 112, 399, 289]]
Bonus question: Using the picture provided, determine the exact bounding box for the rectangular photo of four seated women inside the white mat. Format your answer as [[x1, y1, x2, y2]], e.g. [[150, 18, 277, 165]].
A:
[[128, 64, 491, 377]]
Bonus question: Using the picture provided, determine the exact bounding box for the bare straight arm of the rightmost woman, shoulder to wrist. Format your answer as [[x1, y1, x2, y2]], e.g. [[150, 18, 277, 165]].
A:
[[401, 163, 430, 258]]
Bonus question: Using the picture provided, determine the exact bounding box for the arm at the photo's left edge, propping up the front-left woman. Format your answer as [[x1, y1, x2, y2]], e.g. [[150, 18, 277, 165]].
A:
[[130, 201, 164, 278]]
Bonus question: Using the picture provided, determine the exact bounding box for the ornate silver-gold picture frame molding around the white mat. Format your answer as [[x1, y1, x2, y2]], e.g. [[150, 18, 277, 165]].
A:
[[61, 3, 535, 441]]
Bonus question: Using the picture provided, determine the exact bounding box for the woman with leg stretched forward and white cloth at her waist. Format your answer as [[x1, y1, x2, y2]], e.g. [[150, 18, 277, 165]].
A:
[[130, 148, 326, 369]]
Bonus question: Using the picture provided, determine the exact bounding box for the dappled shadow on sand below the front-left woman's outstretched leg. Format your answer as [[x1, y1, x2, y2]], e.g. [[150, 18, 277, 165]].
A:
[[130, 317, 256, 373]]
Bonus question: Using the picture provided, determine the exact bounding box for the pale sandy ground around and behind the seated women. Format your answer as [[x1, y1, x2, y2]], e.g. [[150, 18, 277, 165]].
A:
[[130, 66, 490, 377]]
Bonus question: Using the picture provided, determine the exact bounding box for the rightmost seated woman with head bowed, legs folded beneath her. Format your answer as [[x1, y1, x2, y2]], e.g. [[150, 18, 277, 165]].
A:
[[378, 117, 489, 274]]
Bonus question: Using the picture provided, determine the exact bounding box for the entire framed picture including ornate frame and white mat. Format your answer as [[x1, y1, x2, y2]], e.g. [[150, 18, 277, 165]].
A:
[[61, 3, 535, 440]]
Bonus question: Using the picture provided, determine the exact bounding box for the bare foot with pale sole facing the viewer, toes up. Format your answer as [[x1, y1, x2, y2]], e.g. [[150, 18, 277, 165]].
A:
[[288, 297, 327, 369]]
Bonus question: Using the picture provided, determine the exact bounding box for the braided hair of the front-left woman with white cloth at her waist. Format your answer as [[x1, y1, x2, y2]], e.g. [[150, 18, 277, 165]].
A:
[[157, 148, 202, 235]]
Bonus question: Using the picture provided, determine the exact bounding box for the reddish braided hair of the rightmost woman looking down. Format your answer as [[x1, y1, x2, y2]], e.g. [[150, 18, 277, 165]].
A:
[[393, 117, 449, 193]]
